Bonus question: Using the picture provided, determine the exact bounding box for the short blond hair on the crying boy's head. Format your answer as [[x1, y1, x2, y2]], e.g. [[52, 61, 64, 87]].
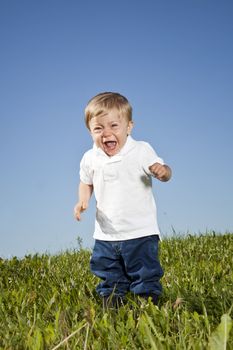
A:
[[85, 92, 132, 129]]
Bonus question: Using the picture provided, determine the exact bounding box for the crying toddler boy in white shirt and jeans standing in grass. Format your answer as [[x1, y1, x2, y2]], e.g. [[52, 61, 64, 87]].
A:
[[74, 92, 171, 305]]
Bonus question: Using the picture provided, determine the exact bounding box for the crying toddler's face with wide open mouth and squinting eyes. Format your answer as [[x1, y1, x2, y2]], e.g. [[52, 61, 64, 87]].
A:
[[89, 109, 133, 157]]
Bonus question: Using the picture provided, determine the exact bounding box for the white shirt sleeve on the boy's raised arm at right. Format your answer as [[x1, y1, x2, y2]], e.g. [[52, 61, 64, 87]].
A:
[[140, 142, 164, 175]]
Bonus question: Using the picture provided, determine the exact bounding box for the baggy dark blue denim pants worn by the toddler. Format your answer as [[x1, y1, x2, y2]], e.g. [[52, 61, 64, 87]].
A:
[[90, 235, 163, 297]]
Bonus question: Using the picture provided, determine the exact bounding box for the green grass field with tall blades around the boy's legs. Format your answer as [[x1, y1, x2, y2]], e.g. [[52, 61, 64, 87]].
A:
[[0, 233, 233, 350]]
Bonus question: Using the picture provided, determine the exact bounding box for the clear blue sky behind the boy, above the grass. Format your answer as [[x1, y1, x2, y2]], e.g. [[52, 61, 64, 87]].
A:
[[0, 0, 233, 258]]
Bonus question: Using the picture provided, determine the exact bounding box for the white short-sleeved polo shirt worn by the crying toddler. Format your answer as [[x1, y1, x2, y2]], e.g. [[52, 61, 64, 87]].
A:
[[80, 136, 164, 241]]
